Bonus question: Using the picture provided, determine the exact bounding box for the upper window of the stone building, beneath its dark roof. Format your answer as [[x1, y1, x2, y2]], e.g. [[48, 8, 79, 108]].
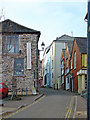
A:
[[3, 35, 19, 53]]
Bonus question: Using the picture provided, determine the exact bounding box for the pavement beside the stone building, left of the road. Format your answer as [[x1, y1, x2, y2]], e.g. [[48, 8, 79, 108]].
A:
[[0, 94, 44, 119]]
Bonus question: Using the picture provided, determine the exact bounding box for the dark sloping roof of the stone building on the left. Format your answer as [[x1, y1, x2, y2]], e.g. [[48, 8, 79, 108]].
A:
[[0, 19, 40, 35]]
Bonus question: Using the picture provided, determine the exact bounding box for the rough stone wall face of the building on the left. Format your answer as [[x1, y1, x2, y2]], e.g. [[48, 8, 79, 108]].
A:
[[2, 34, 38, 90]]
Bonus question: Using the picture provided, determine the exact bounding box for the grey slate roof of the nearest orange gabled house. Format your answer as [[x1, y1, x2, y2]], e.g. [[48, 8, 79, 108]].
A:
[[75, 37, 87, 53]]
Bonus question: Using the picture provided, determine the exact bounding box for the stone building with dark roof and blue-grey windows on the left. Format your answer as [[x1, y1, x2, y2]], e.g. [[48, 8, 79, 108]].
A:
[[0, 19, 40, 90]]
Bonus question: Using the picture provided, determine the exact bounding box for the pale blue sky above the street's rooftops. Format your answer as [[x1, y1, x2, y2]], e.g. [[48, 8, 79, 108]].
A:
[[0, 0, 87, 58]]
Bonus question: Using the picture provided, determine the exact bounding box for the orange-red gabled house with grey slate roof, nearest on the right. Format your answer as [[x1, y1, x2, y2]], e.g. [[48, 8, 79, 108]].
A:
[[70, 37, 87, 91]]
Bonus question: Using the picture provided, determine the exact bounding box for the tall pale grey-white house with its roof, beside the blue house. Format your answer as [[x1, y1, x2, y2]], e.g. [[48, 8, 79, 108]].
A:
[[50, 35, 74, 89]]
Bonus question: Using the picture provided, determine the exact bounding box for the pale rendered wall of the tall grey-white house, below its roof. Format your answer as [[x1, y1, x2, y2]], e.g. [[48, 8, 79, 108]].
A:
[[51, 42, 65, 88]]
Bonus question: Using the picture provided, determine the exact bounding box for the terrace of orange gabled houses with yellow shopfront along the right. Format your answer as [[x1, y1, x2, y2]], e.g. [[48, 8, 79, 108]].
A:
[[61, 37, 87, 94]]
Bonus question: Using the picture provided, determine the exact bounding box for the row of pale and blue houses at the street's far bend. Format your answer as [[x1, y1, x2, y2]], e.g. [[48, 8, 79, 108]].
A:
[[43, 34, 74, 89]]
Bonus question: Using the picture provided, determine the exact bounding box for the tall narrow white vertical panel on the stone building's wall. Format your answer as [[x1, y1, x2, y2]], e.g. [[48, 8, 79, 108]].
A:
[[27, 43, 31, 69]]
